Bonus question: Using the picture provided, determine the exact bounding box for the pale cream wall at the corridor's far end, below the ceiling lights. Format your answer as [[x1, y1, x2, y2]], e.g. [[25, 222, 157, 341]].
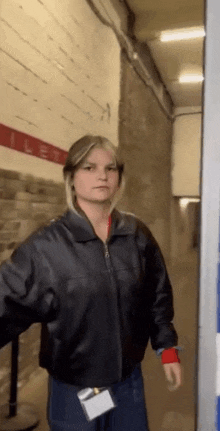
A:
[[172, 107, 202, 197]]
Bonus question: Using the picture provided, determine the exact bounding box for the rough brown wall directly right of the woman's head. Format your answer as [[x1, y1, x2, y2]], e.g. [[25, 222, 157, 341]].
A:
[[120, 54, 172, 261]]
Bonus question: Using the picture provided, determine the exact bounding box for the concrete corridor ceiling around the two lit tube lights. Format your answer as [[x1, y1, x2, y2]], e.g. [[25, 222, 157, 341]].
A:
[[127, 0, 204, 107]]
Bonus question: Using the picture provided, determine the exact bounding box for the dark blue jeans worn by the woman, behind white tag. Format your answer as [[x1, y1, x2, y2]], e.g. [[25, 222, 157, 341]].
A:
[[48, 365, 149, 431]]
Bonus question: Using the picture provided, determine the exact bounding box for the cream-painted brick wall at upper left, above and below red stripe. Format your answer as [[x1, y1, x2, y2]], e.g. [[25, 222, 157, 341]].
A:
[[0, 0, 120, 181]]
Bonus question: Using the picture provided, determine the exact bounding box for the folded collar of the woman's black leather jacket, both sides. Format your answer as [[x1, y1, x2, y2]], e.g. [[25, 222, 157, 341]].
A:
[[61, 210, 135, 242]]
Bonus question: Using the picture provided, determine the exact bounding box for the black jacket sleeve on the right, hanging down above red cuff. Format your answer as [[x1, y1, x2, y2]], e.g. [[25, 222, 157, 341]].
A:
[[146, 237, 178, 350]]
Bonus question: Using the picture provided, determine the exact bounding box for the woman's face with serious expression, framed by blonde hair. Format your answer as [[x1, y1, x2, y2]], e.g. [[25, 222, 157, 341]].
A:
[[73, 148, 119, 203]]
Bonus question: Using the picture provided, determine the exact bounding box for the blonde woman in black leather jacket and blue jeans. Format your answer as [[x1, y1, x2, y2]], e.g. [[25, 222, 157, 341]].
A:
[[0, 135, 181, 431]]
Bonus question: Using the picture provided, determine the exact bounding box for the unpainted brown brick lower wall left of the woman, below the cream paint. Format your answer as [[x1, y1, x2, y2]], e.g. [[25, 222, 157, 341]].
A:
[[0, 169, 66, 405]]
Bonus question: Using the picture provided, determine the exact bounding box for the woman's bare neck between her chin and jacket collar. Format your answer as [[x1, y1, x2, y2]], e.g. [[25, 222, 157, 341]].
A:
[[77, 199, 111, 227]]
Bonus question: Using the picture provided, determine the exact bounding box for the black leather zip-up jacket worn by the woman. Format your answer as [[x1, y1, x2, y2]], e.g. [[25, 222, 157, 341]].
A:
[[0, 210, 177, 387]]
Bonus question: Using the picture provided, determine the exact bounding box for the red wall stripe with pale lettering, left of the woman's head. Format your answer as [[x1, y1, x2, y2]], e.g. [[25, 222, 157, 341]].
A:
[[0, 124, 67, 165]]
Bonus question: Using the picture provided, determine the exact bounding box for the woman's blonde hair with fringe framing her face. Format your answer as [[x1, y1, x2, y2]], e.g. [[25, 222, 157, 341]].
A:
[[63, 135, 125, 212]]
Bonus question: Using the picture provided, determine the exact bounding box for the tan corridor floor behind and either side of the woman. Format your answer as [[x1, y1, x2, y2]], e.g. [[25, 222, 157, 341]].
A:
[[19, 250, 198, 431]]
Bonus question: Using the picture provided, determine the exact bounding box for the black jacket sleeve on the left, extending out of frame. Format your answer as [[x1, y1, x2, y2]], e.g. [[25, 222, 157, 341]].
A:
[[0, 242, 56, 348]]
